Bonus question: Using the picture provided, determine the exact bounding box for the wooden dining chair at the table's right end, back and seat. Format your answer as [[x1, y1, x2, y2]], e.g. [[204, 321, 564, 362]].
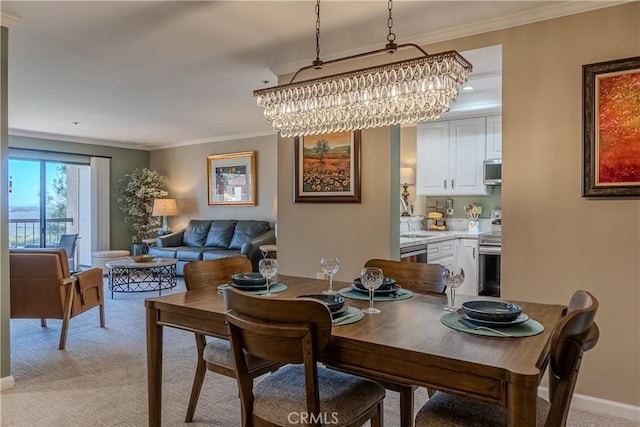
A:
[[415, 290, 600, 427]]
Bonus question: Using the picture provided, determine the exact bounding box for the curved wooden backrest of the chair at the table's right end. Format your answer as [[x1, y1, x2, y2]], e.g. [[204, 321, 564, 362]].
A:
[[546, 290, 600, 427]]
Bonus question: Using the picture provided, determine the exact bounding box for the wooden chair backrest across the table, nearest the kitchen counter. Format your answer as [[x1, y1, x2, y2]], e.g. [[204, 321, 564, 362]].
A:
[[365, 258, 446, 294]]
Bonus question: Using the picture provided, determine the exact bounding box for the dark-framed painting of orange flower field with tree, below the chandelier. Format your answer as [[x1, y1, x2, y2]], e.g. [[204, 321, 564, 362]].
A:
[[294, 130, 360, 203]]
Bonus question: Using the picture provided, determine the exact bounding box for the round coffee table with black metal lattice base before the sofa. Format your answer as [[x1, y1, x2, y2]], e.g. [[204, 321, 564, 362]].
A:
[[105, 258, 178, 299]]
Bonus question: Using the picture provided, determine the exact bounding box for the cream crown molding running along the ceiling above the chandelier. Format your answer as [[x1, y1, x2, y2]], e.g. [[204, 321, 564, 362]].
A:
[[271, 0, 637, 76]]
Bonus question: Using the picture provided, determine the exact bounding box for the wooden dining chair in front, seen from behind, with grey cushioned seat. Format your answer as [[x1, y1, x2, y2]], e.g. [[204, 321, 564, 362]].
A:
[[224, 288, 385, 427]]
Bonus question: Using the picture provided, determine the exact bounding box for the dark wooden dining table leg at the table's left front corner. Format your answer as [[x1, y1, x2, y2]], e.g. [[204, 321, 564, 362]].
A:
[[147, 307, 163, 427]]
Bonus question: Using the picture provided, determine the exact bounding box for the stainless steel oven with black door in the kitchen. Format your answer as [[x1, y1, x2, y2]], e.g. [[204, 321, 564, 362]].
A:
[[478, 232, 502, 297]]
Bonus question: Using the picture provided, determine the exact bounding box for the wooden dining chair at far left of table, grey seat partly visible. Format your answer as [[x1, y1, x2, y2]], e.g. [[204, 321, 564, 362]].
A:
[[183, 256, 279, 423]]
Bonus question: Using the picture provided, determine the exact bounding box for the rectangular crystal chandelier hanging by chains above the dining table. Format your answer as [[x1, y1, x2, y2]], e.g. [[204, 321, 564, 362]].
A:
[[253, 0, 472, 137]]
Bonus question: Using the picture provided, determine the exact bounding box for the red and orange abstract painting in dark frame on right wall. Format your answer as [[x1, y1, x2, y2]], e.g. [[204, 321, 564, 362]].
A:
[[582, 57, 640, 197]]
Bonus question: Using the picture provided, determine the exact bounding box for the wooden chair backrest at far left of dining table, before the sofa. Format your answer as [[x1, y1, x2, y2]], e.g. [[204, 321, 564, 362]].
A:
[[183, 256, 253, 290]]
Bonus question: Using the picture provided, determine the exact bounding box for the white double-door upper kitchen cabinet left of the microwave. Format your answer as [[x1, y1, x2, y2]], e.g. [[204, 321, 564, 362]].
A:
[[416, 117, 488, 196]]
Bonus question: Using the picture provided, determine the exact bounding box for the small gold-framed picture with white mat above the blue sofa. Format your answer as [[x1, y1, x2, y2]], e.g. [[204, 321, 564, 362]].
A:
[[207, 151, 256, 206]]
